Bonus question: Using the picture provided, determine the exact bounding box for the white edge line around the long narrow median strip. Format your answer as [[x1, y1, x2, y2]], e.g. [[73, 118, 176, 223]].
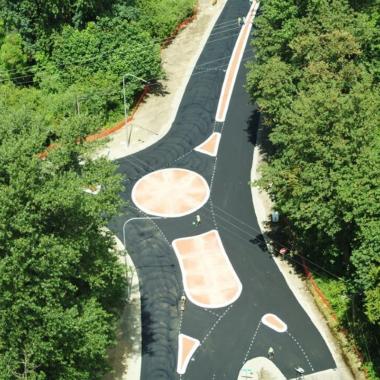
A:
[[215, 2, 259, 123]]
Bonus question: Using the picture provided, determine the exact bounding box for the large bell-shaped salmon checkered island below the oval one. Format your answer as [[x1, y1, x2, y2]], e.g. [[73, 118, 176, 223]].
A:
[[172, 230, 242, 308]]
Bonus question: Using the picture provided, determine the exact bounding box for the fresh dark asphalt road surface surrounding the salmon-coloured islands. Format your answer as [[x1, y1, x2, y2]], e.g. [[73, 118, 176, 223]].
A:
[[110, 0, 335, 380]]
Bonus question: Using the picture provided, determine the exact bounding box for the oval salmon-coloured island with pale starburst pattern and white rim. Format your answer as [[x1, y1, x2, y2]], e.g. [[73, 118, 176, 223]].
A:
[[132, 168, 210, 218]]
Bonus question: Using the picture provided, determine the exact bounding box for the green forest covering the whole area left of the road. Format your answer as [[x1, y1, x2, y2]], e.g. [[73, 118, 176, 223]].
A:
[[0, 0, 196, 380]]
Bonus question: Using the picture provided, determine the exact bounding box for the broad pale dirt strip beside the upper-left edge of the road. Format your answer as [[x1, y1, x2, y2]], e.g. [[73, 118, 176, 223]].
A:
[[100, 0, 227, 160]]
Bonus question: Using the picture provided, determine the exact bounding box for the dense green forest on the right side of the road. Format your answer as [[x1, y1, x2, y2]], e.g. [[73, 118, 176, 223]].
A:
[[247, 0, 380, 379]]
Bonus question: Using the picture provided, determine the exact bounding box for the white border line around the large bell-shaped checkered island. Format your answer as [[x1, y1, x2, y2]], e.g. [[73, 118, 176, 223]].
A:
[[172, 230, 243, 309]]
